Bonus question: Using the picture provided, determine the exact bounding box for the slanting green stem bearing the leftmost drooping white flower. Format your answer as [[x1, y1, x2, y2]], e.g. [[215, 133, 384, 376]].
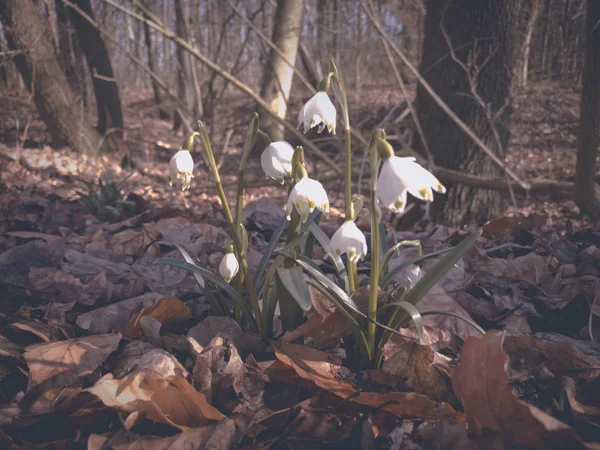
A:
[[194, 122, 265, 335]]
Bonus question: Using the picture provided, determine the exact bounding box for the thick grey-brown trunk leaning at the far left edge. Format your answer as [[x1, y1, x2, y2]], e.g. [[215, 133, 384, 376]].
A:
[[0, 0, 101, 154]]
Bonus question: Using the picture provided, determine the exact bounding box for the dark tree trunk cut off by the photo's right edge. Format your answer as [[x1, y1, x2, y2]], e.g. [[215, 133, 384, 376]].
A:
[[575, 0, 600, 219]]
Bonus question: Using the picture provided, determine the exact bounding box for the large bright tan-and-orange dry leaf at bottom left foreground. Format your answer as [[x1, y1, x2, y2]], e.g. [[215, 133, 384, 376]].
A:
[[87, 372, 225, 430]]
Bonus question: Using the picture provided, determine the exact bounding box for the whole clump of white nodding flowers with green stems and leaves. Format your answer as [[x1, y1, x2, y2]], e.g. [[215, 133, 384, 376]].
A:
[[157, 61, 483, 368]]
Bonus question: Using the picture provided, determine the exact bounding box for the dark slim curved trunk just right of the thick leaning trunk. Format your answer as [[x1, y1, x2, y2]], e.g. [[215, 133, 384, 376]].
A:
[[71, 0, 123, 135]]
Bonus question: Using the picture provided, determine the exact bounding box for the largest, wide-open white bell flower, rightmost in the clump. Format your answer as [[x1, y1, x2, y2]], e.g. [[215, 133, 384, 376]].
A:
[[377, 156, 446, 213]]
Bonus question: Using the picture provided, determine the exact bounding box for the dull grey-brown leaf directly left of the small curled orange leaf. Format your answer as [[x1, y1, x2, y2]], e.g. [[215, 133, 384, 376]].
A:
[[77, 292, 160, 334]]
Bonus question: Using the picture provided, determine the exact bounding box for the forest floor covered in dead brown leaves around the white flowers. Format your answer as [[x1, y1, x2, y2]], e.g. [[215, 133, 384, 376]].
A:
[[0, 83, 600, 450]]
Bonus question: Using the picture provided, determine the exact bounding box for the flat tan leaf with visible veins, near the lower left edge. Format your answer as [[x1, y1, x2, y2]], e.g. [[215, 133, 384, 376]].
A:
[[24, 333, 121, 400]]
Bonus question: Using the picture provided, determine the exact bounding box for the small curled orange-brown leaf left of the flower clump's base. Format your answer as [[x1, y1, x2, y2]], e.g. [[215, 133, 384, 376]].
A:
[[122, 297, 191, 339]]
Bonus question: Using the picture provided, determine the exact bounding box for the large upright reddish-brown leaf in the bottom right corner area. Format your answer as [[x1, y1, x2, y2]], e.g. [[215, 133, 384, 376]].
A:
[[452, 331, 584, 449]]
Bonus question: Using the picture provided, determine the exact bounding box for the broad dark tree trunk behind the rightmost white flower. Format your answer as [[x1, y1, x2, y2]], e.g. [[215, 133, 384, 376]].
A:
[[416, 0, 527, 226]]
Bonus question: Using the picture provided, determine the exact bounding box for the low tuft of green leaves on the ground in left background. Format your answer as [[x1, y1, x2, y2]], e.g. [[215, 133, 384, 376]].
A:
[[77, 172, 135, 222]]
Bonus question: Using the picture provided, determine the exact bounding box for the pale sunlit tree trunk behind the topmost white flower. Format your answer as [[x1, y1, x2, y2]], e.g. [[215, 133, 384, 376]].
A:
[[260, 0, 304, 141]]
